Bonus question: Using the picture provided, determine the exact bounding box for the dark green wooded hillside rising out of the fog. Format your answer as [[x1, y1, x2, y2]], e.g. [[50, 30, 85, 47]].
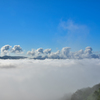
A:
[[66, 84, 100, 100]]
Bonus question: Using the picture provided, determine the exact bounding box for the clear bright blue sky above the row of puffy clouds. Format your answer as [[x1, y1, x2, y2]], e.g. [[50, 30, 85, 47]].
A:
[[0, 0, 100, 51]]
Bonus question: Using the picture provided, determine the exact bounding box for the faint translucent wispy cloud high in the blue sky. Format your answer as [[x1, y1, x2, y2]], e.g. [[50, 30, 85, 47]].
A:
[[55, 20, 89, 48]]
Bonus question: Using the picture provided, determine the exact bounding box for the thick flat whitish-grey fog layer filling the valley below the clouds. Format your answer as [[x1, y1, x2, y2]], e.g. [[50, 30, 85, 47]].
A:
[[0, 59, 100, 100]]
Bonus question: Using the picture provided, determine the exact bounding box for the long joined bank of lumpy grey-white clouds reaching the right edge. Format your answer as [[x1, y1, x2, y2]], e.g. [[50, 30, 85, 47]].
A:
[[27, 47, 100, 59]]
